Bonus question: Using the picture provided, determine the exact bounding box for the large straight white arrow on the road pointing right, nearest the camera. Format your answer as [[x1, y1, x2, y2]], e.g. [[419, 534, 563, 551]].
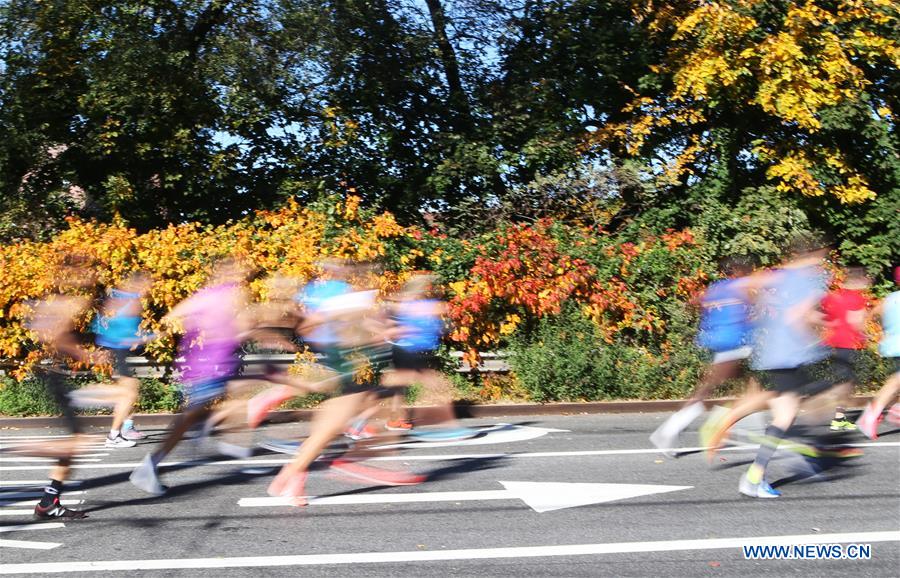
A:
[[238, 482, 693, 512]]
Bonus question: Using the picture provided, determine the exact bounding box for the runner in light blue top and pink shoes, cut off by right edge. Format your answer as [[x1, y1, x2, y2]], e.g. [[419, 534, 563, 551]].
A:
[[856, 267, 900, 440]]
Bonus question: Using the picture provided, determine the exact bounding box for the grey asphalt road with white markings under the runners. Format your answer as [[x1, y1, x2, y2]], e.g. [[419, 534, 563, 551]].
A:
[[0, 414, 900, 577]]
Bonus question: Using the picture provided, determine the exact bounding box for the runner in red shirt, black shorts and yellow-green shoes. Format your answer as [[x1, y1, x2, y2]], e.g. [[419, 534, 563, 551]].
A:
[[822, 267, 870, 431]]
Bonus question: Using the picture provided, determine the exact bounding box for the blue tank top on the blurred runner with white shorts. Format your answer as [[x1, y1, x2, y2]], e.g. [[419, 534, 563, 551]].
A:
[[697, 279, 750, 352]]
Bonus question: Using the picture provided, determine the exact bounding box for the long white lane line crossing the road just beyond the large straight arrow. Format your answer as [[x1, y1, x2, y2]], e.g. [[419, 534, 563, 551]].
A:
[[0, 442, 900, 472]]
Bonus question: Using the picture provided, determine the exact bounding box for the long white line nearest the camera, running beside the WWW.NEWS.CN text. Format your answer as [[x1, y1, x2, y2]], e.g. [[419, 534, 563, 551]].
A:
[[0, 531, 900, 574]]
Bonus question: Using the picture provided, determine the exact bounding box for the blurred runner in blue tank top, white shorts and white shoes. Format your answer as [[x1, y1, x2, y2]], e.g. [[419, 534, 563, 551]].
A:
[[650, 257, 758, 453]]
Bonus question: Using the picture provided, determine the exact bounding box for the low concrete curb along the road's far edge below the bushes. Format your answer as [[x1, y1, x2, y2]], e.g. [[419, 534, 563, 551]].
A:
[[0, 396, 872, 428]]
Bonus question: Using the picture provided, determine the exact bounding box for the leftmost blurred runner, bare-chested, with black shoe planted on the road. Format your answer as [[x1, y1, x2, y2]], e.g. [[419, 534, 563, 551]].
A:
[[29, 254, 105, 520]]
